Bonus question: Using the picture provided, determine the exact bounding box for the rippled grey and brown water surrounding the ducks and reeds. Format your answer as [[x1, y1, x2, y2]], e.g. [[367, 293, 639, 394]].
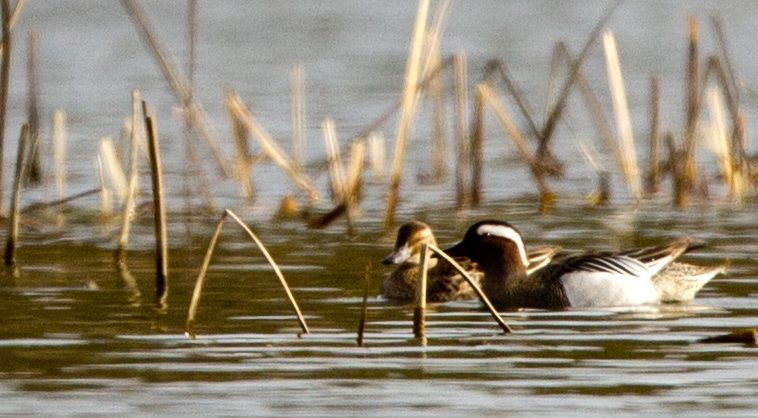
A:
[[0, 1, 758, 417]]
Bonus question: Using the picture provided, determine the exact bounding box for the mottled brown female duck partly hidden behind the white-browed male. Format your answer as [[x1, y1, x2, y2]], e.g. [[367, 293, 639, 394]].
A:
[[382, 221, 559, 302]]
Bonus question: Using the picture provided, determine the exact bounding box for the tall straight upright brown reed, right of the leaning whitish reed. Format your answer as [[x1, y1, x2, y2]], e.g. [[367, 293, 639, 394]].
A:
[[676, 15, 700, 207]]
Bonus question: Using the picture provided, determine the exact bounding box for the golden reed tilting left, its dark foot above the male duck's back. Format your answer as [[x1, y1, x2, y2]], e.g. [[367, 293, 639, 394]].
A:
[[476, 83, 554, 208]]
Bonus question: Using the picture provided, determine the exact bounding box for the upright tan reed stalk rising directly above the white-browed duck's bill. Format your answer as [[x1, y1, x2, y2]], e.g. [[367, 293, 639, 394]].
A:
[[453, 51, 469, 210]]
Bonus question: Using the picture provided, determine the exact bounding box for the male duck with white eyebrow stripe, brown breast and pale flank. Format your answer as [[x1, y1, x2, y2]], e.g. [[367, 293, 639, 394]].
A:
[[446, 221, 725, 309]]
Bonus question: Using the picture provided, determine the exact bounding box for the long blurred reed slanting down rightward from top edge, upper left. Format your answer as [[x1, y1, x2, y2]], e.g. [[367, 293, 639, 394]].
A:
[[121, 0, 232, 178]]
